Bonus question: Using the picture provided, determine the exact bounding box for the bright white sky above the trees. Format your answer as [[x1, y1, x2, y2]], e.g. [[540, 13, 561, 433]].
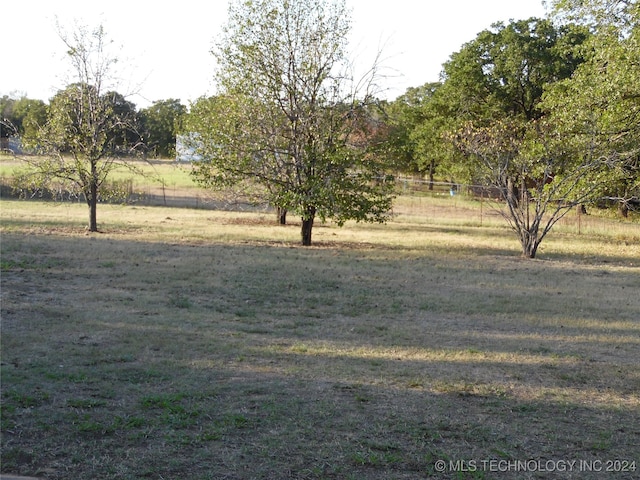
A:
[[0, 0, 546, 108]]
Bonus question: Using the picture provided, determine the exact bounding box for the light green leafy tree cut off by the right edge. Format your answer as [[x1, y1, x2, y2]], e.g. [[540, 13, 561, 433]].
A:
[[544, 0, 640, 216]]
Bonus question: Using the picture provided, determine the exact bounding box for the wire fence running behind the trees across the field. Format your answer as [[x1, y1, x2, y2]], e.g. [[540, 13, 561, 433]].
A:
[[0, 167, 640, 238]]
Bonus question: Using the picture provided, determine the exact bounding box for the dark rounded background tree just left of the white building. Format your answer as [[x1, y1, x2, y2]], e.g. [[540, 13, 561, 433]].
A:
[[140, 98, 187, 158]]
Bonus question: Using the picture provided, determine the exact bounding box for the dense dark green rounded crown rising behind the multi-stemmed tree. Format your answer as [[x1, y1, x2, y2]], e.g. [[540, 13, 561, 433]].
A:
[[443, 18, 588, 120]]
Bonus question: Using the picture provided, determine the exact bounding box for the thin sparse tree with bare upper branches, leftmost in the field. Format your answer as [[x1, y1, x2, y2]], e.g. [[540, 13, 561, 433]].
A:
[[28, 26, 137, 232]]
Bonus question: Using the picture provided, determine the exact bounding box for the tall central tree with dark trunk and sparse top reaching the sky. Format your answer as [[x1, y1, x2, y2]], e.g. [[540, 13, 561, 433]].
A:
[[187, 0, 393, 245]]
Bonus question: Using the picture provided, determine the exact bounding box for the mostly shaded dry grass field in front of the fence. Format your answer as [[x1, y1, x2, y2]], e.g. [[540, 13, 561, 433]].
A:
[[0, 198, 640, 480]]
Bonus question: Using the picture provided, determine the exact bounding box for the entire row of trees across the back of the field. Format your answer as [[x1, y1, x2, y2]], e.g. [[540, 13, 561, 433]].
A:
[[2, 0, 640, 258]]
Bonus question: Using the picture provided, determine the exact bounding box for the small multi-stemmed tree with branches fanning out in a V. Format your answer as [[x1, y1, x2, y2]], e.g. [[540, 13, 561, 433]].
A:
[[454, 117, 607, 258]]
